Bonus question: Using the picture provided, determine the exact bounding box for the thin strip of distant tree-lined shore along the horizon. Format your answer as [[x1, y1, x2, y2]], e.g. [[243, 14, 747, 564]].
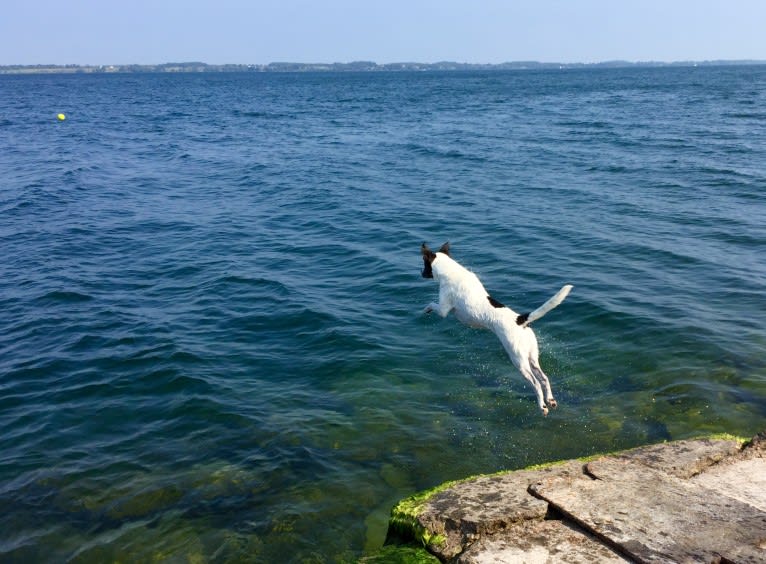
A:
[[0, 60, 766, 74]]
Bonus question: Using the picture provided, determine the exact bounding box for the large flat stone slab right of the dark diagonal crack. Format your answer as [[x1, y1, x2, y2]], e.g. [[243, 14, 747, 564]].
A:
[[530, 457, 766, 563]]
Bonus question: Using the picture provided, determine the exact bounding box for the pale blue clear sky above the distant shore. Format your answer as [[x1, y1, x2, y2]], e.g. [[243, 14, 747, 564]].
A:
[[0, 0, 766, 65]]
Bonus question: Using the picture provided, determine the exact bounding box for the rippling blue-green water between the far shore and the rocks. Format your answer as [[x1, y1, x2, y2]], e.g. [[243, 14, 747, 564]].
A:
[[0, 67, 766, 562]]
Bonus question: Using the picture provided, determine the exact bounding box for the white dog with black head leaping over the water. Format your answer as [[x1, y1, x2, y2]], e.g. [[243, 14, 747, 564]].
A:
[[421, 243, 572, 415]]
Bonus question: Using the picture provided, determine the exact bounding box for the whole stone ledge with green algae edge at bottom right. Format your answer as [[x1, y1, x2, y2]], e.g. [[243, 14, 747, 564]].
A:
[[380, 433, 766, 564]]
